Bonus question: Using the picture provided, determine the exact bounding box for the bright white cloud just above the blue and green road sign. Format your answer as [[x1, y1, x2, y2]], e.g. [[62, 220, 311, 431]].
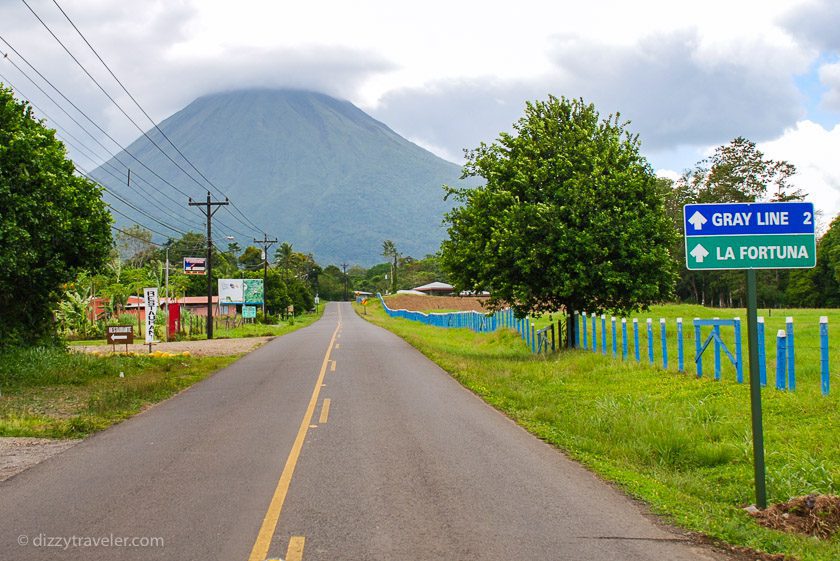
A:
[[758, 121, 840, 222]]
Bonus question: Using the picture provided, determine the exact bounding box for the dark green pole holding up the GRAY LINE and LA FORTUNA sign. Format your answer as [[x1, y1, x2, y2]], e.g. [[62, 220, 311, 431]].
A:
[[747, 269, 767, 509]]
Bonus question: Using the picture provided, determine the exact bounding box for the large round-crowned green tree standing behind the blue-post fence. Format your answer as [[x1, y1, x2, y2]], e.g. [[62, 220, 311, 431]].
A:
[[441, 96, 675, 344]]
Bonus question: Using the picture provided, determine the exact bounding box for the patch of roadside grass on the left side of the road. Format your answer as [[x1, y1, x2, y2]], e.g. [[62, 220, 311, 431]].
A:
[[0, 348, 242, 438]]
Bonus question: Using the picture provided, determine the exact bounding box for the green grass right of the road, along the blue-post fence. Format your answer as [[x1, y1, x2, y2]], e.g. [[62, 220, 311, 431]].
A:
[[357, 303, 840, 561]]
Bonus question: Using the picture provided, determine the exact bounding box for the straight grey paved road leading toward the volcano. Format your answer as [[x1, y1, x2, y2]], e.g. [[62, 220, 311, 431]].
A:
[[0, 304, 722, 561]]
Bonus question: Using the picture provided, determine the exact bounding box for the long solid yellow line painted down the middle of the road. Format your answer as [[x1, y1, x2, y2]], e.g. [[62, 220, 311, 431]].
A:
[[248, 320, 341, 561]]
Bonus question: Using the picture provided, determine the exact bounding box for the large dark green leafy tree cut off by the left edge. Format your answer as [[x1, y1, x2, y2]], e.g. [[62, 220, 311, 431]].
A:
[[0, 85, 112, 345]]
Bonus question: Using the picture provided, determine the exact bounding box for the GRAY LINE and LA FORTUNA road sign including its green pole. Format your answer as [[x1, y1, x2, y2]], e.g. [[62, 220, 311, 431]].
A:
[[683, 202, 817, 508]]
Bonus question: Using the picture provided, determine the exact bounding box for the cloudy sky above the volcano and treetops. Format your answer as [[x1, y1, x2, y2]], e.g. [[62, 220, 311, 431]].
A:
[[0, 0, 840, 222]]
